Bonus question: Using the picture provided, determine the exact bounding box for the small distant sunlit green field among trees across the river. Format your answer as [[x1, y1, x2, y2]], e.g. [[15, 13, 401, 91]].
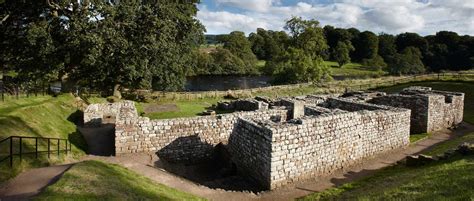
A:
[[324, 61, 387, 78]]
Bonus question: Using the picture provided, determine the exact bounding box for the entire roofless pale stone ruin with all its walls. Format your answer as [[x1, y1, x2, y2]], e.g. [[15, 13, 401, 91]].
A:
[[84, 87, 464, 189]]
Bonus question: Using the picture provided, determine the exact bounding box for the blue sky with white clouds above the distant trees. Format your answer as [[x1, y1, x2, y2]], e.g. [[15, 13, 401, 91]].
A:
[[197, 0, 474, 35]]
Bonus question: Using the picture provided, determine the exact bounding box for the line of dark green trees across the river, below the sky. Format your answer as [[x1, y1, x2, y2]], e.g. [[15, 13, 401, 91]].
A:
[[193, 17, 474, 83]]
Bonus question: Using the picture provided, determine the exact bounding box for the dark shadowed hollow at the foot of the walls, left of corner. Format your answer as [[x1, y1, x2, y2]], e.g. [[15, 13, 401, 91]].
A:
[[154, 135, 263, 192]]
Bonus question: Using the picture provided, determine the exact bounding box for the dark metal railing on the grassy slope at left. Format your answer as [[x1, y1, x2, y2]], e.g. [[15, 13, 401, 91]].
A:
[[0, 136, 71, 167]]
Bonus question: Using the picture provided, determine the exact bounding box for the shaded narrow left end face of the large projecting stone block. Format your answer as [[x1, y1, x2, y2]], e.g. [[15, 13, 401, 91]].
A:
[[227, 119, 272, 188]]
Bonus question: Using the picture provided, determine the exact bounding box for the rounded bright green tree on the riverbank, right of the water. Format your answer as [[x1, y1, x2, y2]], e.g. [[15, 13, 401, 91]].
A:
[[274, 47, 329, 83]]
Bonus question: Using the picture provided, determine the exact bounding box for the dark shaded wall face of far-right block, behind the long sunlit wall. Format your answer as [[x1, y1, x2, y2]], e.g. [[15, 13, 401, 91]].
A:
[[369, 95, 429, 133]]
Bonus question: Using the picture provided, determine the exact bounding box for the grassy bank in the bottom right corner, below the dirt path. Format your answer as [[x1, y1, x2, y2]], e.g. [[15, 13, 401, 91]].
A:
[[300, 156, 474, 200]]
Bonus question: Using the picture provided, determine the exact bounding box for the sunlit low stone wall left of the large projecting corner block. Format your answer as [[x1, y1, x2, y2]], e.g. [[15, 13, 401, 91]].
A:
[[115, 110, 287, 162]]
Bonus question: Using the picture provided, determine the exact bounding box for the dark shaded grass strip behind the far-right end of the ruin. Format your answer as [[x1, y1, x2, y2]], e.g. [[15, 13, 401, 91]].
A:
[[375, 81, 474, 124]]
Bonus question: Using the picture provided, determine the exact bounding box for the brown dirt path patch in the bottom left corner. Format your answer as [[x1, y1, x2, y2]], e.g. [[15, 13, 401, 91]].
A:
[[0, 164, 72, 201]]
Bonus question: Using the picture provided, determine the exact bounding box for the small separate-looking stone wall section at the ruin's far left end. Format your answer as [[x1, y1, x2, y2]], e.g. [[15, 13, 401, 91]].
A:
[[84, 101, 138, 126]]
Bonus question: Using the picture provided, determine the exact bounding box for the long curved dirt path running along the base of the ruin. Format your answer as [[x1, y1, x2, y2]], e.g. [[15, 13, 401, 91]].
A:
[[84, 123, 474, 201]]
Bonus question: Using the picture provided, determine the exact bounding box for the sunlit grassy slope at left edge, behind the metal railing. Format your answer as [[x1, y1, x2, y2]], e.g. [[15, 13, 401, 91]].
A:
[[0, 95, 85, 181]]
